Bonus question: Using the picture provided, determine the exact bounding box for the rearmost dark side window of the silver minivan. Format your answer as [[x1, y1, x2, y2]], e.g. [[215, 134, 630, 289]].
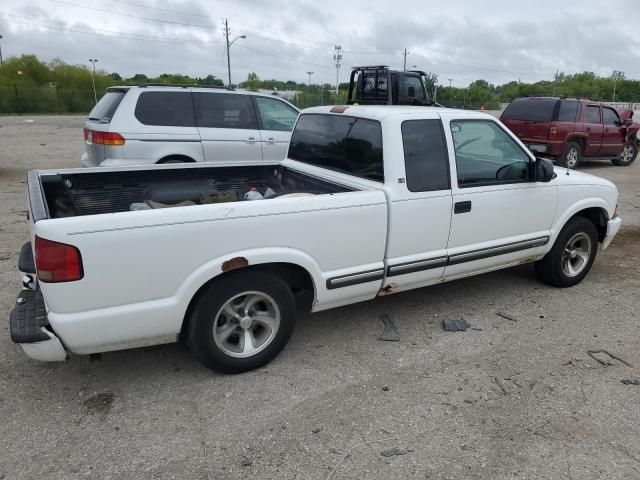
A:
[[135, 92, 196, 127]]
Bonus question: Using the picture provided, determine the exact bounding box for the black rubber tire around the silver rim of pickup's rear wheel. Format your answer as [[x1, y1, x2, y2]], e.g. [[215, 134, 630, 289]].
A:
[[185, 271, 296, 373]]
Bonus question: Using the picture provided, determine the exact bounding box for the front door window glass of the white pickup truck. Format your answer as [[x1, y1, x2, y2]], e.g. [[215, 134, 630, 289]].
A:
[[451, 120, 530, 187]]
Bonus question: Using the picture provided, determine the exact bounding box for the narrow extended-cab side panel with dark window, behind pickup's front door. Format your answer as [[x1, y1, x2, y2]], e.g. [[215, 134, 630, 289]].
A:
[[385, 114, 452, 291]]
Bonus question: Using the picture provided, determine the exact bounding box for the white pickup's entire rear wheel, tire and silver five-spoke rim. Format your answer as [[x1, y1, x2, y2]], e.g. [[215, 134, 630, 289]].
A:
[[186, 271, 296, 373]]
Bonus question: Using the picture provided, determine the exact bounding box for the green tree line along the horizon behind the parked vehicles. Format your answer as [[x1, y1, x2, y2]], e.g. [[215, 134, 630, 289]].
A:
[[0, 55, 640, 113]]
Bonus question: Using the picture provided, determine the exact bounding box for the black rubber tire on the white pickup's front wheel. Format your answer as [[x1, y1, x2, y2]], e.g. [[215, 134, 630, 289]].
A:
[[535, 217, 598, 288]]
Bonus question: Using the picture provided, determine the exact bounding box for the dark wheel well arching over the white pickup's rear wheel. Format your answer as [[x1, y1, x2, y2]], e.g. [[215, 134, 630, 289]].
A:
[[182, 263, 315, 338]]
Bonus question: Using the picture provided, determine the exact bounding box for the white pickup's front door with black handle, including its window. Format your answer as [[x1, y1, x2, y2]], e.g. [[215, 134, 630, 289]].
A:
[[444, 117, 557, 279]]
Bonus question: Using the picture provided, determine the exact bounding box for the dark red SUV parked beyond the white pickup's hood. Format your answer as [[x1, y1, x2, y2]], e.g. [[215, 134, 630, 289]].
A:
[[500, 97, 640, 168]]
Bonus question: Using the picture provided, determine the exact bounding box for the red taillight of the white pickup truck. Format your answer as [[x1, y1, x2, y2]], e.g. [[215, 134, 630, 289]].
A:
[[36, 237, 84, 283]]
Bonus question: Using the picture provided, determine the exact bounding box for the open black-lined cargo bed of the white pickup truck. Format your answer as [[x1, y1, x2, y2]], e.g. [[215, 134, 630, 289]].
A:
[[29, 165, 353, 221]]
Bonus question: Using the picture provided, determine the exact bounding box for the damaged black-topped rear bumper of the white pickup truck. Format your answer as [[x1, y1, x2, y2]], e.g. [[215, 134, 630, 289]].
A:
[[9, 290, 67, 362]]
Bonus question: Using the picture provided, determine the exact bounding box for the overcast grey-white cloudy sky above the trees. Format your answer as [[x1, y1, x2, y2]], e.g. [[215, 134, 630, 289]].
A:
[[0, 0, 640, 86]]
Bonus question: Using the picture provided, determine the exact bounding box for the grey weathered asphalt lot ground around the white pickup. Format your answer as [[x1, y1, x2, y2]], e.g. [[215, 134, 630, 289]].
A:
[[0, 116, 640, 480]]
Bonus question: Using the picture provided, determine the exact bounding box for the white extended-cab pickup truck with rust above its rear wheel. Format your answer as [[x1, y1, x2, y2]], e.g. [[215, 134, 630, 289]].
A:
[[10, 106, 621, 372]]
